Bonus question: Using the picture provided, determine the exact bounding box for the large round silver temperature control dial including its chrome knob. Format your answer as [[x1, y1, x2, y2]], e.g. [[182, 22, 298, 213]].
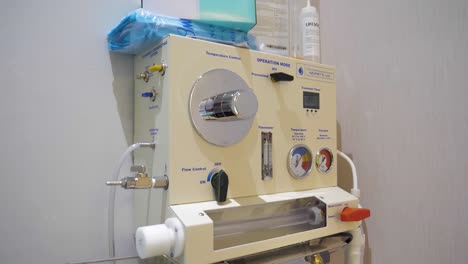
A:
[[189, 69, 258, 146]]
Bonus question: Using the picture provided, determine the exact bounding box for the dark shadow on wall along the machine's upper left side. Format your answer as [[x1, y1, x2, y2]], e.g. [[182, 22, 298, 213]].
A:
[[109, 52, 134, 145]]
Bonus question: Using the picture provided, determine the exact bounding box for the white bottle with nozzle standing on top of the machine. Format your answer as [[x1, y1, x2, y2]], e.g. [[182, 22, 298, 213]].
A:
[[300, 0, 320, 63]]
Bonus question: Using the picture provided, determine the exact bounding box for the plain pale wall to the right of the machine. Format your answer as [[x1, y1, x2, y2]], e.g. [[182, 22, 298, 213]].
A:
[[321, 0, 468, 264]]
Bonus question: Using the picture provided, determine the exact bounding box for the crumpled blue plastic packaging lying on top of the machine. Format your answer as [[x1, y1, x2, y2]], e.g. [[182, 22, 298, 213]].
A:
[[107, 9, 257, 54]]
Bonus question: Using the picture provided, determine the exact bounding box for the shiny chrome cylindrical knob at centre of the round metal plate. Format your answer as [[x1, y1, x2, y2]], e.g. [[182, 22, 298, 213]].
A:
[[199, 89, 258, 120]]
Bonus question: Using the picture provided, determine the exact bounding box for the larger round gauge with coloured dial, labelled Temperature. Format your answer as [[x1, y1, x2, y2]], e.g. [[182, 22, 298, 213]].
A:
[[288, 145, 312, 179]]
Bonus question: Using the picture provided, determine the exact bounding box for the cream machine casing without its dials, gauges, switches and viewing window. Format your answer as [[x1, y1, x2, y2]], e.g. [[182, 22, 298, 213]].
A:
[[134, 35, 359, 263]]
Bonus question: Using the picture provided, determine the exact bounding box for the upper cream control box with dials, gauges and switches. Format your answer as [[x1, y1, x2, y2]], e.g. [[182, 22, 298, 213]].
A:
[[134, 36, 337, 208]]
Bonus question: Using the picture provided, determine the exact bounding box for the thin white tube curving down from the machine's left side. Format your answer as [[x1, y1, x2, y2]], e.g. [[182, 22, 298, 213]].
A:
[[107, 143, 156, 258]]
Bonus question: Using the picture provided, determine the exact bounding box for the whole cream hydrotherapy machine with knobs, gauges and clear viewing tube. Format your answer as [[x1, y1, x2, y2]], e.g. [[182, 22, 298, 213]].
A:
[[109, 35, 370, 264]]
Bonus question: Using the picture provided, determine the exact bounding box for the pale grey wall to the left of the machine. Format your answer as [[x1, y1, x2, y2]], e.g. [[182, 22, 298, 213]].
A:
[[0, 0, 139, 263]]
